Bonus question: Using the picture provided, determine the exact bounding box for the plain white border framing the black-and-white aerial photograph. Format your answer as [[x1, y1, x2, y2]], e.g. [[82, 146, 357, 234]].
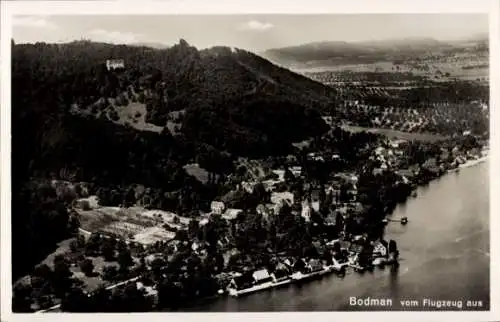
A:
[[0, 0, 500, 322]]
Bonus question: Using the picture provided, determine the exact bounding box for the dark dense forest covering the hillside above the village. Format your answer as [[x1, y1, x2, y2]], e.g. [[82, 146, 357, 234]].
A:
[[12, 40, 335, 278]]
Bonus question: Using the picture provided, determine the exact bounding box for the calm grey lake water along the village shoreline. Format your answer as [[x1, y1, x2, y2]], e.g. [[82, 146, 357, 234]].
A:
[[188, 162, 490, 312]]
